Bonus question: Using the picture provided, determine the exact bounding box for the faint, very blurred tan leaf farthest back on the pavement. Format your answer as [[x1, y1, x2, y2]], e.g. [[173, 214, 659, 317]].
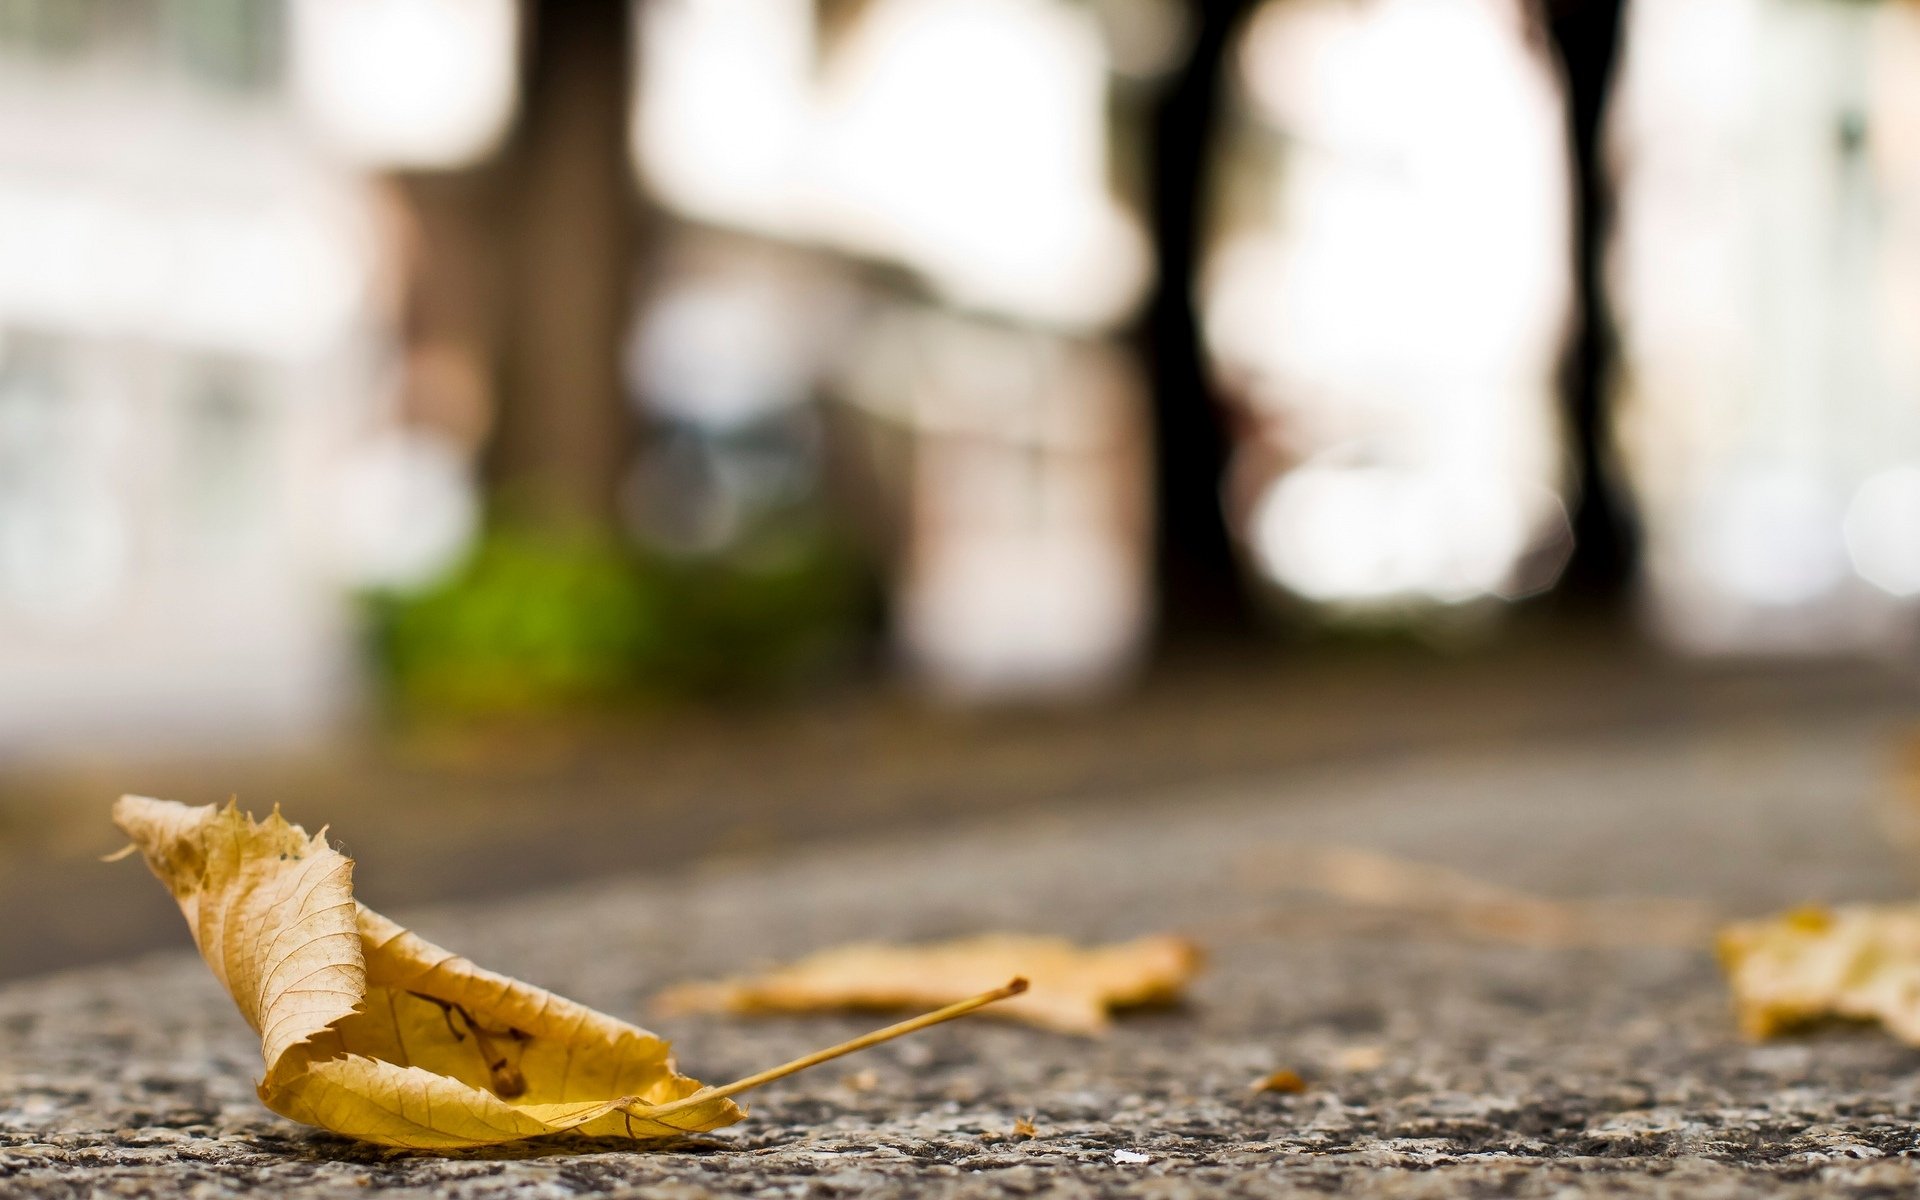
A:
[[1240, 843, 1716, 948]]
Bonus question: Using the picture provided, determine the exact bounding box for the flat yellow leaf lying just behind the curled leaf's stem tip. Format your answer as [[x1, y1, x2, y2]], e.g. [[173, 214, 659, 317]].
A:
[[655, 933, 1200, 1035]]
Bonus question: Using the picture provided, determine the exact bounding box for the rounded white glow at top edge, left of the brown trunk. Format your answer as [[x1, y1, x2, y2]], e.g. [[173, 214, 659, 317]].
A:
[[292, 0, 520, 169]]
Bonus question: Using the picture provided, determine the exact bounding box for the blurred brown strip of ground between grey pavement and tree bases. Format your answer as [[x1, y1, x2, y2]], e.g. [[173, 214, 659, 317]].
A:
[[0, 624, 1920, 981]]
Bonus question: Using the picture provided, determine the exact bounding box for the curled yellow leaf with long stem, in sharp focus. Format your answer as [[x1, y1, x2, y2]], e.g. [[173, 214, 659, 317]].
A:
[[113, 797, 1025, 1150]]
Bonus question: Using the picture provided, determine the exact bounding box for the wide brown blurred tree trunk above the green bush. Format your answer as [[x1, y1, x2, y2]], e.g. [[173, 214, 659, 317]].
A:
[[488, 0, 637, 524]]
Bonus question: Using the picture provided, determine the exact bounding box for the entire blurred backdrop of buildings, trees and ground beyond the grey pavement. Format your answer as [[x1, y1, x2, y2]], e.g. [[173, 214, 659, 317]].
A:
[[0, 0, 1920, 975]]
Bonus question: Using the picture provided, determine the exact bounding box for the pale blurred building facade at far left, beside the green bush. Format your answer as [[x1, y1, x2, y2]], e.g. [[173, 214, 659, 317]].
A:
[[0, 2, 382, 749]]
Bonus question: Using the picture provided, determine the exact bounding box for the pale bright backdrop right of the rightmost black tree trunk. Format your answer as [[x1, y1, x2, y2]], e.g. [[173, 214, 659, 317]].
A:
[[1607, 0, 1920, 653]]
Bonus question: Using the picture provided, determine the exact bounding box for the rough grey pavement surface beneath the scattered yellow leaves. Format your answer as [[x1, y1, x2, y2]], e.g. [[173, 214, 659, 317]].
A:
[[11, 706, 1920, 1200]]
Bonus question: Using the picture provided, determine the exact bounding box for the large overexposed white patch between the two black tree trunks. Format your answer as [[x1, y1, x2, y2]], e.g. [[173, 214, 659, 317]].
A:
[[1208, 0, 1571, 387]]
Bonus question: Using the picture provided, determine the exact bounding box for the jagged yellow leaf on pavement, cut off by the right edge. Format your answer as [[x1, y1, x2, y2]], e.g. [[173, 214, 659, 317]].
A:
[[1720, 904, 1920, 1046]]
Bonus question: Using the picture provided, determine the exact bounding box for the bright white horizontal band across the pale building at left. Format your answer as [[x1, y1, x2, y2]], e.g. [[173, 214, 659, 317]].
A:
[[0, 173, 372, 359]]
